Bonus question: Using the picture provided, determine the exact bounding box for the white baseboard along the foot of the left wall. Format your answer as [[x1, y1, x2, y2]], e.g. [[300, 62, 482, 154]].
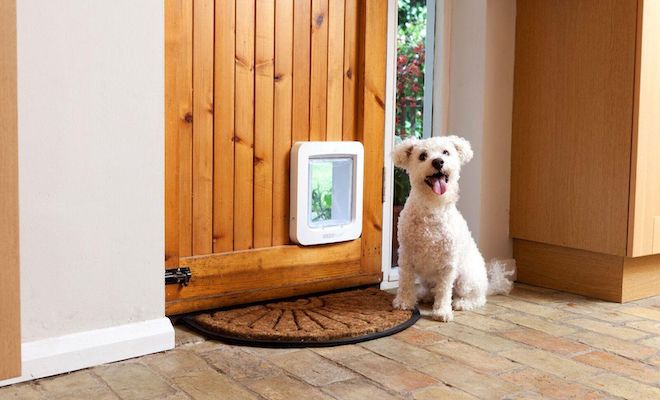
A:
[[0, 317, 174, 387]]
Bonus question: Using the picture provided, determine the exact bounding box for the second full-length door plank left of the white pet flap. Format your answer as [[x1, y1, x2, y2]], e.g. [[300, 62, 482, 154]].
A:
[[254, 0, 275, 248]]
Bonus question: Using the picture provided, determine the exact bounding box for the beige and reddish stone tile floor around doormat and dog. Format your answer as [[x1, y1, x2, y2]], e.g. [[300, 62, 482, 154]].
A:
[[0, 285, 660, 400]]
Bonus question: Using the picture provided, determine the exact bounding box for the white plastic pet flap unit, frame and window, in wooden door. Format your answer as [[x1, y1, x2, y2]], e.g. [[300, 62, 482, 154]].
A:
[[289, 142, 364, 246]]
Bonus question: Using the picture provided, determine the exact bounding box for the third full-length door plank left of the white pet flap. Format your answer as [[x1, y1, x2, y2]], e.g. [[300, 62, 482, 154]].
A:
[[234, 1, 255, 250]]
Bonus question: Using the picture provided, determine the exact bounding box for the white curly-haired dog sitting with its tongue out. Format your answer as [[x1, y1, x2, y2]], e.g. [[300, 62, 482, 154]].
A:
[[392, 136, 512, 321]]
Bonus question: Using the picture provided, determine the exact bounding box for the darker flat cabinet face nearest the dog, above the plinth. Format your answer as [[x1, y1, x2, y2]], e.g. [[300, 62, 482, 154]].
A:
[[511, 0, 637, 255]]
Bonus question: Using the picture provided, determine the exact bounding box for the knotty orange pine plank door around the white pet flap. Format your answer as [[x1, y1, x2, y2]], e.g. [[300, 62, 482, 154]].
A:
[[165, 0, 387, 314]]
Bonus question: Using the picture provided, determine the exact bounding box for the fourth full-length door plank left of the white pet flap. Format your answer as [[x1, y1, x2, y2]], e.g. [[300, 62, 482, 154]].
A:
[[213, 0, 236, 253]]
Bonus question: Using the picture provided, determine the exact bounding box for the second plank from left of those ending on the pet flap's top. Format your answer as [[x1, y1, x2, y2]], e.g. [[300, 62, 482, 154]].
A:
[[309, 0, 328, 140]]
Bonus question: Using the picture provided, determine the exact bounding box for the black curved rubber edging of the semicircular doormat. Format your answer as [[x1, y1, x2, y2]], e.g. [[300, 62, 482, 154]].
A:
[[182, 307, 421, 349]]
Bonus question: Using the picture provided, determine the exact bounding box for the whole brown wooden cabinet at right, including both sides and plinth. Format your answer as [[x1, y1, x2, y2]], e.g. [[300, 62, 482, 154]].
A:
[[511, 0, 660, 301]]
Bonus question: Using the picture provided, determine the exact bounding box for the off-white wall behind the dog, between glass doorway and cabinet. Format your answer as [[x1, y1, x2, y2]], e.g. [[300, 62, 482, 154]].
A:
[[447, 0, 516, 259]]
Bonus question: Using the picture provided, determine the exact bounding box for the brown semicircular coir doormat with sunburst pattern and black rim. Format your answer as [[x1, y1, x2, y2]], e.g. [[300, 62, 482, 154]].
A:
[[183, 288, 420, 347]]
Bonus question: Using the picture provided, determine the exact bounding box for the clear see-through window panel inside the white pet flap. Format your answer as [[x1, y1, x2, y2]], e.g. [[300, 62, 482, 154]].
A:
[[307, 157, 354, 228]]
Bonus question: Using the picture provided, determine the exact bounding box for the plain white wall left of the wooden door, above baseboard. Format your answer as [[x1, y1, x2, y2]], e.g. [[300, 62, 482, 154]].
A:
[[17, 0, 164, 342]]
